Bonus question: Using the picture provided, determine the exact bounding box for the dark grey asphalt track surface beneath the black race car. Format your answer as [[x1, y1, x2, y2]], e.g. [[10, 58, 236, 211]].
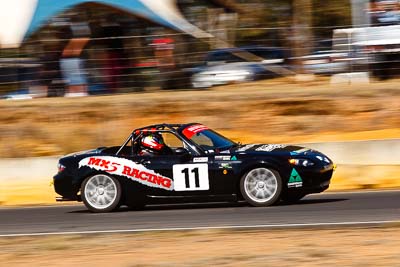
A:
[[0, 191, 400, 237]]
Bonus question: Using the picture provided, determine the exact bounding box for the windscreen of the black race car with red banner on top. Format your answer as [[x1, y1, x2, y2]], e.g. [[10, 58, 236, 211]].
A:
[[182, 124, 236, 152]]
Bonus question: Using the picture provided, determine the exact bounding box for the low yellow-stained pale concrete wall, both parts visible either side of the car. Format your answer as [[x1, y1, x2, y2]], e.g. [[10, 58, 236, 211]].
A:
[[0, 139, 400, 205]]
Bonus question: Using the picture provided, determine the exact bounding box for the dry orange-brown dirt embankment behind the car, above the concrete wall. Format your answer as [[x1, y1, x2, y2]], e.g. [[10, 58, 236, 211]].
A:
[[0, 77, 400, 157]]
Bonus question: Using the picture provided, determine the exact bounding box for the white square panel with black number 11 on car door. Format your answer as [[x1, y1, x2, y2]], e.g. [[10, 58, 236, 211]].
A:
[[172, 164, 210, 191]]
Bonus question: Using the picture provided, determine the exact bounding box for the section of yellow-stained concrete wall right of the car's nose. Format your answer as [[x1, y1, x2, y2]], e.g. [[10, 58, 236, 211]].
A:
[[300, 139, 400, 190]]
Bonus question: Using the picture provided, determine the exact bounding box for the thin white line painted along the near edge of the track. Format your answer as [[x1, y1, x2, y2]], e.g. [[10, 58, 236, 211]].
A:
[[0, 220, 400, 237]]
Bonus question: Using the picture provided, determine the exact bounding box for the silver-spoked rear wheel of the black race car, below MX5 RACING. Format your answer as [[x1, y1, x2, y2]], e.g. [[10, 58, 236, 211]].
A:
[[81, 174, 122, 215]]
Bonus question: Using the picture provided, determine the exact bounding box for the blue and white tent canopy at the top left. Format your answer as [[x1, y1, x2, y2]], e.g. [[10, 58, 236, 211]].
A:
[[0, 0, 212, 46]]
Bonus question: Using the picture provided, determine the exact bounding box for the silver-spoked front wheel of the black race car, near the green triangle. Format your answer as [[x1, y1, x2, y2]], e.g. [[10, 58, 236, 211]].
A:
[[240, 168, 282, 207]]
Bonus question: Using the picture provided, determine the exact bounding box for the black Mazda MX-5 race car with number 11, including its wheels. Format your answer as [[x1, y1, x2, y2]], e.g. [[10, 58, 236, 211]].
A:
[[54, 123, 334, 212]]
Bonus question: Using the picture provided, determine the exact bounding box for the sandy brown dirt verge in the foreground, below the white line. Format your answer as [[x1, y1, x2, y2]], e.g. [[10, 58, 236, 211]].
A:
[[0, 227, 400, 267]]
